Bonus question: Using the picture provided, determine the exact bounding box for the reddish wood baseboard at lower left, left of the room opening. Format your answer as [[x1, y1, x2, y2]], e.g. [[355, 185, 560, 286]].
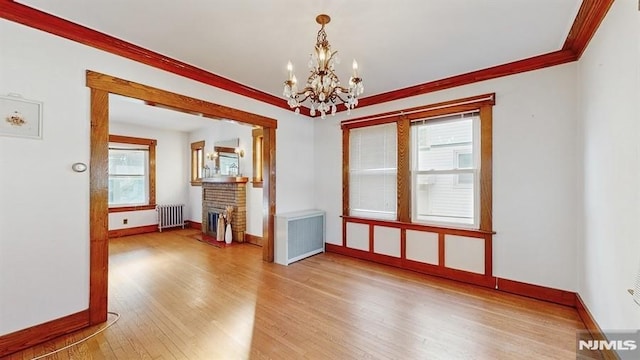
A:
[[0, 310, 89, 357]]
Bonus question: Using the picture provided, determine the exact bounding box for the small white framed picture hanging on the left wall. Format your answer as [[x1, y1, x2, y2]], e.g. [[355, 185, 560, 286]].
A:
[[0, 95, 42, 139]]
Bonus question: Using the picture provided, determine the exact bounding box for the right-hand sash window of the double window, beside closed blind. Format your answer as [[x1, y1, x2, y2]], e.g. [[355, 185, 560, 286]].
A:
[[411, 112, 479, 227]]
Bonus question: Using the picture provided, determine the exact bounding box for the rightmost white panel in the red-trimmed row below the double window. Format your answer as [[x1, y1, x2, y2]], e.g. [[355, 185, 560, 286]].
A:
[[444, 234, 485, 274]]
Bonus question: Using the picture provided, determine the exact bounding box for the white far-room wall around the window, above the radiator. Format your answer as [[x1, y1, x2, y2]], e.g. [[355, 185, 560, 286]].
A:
[[109, 119, 191, 230]]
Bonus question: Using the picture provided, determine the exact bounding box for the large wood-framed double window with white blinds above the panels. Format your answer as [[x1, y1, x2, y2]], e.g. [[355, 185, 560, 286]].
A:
[[341, 94, 495, 231]]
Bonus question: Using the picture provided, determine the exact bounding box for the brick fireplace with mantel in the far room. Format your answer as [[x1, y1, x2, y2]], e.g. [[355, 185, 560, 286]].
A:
[[202, 176, 248, 242]]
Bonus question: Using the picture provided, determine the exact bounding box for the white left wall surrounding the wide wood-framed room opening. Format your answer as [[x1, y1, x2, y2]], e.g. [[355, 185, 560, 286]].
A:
[[0, 19, 314, 335]]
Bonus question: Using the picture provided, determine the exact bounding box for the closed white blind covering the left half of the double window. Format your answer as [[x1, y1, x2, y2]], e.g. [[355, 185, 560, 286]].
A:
[[349, 123, 398, 220]]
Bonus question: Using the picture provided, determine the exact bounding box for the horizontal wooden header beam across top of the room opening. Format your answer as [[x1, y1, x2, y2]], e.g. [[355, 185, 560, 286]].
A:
[[87, 70, 277, 128]]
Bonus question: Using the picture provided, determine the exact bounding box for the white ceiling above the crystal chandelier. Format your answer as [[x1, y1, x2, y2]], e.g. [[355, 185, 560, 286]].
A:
[[18, 0, 581, 101]]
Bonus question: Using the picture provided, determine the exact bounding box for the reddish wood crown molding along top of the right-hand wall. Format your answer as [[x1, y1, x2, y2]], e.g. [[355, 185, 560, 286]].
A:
[[562, 0, 614, 59]]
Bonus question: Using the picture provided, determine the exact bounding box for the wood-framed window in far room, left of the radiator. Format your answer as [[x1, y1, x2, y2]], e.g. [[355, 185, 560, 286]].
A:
[[109, 135, 156, 211]]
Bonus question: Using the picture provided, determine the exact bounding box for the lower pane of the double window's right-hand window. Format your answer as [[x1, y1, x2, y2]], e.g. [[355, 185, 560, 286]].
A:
[[414, 172, 475, 225]]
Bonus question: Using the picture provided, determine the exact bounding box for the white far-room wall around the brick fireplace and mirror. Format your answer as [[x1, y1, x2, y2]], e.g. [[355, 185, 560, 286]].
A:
[[189, 119, 263, 236]]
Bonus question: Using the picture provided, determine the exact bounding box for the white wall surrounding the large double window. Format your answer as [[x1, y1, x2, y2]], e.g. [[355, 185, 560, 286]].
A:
[[315, 63, 578, 291]]
